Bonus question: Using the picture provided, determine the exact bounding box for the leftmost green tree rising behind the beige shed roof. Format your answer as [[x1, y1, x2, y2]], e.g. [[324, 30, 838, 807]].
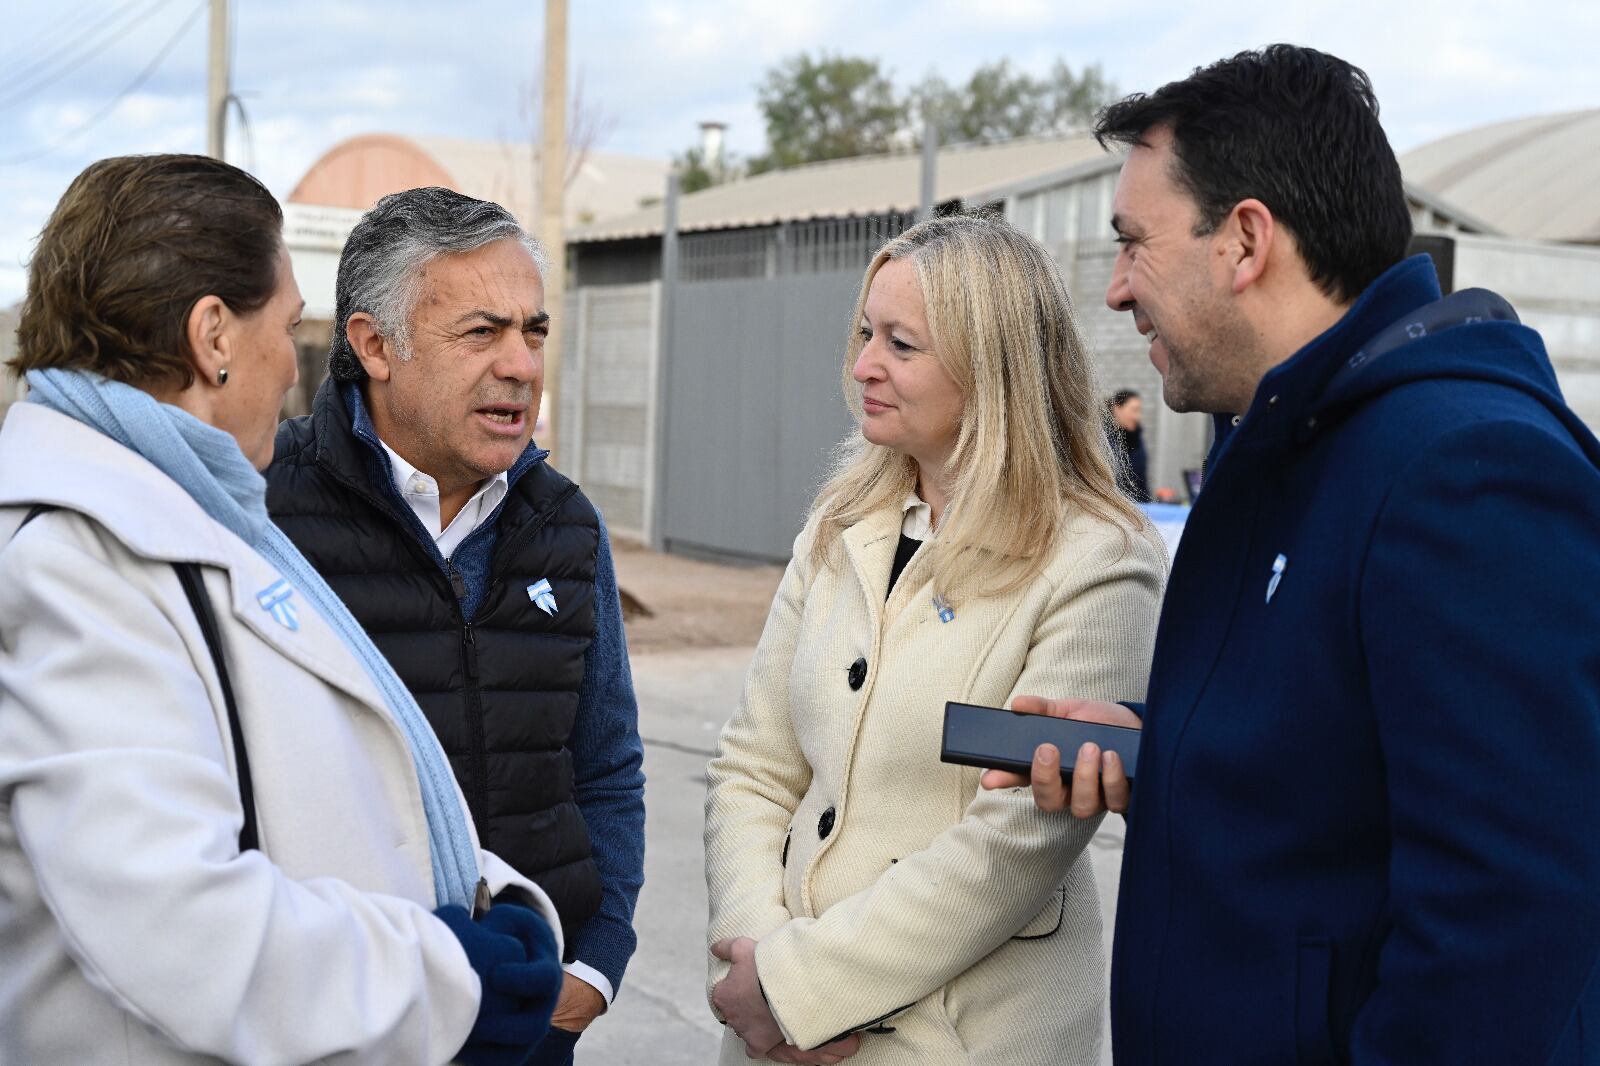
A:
[[749, 53, 910, 174]]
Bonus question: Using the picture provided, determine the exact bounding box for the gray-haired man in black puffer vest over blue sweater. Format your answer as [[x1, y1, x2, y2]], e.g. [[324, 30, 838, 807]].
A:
[[267, 189, 645, 1063]]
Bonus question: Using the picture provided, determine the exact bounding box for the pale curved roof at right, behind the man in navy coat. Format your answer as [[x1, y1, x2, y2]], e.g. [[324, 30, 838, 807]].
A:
[[1400, 107, 1600, 242]]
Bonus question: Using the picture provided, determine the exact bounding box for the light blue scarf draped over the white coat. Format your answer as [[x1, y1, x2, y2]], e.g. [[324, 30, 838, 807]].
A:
[[27, 370, 478, 911]]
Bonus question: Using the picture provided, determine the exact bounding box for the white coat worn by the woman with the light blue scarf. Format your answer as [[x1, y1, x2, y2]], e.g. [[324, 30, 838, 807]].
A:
[[0, 403, 560, 1066]]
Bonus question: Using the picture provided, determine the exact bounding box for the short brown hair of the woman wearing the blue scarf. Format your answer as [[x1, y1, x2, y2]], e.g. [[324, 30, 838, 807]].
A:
[[10, 155, 283, 389]]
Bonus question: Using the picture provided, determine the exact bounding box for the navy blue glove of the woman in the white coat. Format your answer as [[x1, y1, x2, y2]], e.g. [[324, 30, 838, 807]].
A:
[[434, 903, 565, 1066]]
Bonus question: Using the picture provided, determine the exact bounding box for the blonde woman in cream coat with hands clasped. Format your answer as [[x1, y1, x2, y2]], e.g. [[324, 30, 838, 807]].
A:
[[706, 216, 1165, 1066]]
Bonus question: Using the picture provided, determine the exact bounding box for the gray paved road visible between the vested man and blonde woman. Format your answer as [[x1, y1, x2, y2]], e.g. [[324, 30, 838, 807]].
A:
[[576, 648, 1122, 1066]]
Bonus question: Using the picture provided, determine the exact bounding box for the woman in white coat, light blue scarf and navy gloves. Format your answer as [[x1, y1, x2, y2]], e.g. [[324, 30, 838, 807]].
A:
[[0, 155, 560, 1064]]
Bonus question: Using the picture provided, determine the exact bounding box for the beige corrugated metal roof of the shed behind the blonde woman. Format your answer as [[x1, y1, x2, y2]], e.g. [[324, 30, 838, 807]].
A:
[[568, 133, 1104, 243]]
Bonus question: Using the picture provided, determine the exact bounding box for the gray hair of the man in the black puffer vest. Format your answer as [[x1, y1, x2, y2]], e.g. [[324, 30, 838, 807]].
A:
[[328, 186, 550, 381]]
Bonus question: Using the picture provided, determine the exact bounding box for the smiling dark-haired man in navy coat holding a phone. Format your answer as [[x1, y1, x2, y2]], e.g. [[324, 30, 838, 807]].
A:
[[986, 45, 1600, 1066]]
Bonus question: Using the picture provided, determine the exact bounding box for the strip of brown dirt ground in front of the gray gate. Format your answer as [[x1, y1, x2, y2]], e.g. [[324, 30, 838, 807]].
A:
[[611, 539, 784, 651]]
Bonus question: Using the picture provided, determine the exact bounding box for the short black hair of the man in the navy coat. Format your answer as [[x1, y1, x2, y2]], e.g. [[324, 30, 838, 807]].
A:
[[1094, 45, 1411, 303]]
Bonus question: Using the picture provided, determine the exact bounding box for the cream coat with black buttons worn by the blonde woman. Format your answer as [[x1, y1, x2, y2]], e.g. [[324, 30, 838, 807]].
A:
[[706, 509, 1166, 1066]]
